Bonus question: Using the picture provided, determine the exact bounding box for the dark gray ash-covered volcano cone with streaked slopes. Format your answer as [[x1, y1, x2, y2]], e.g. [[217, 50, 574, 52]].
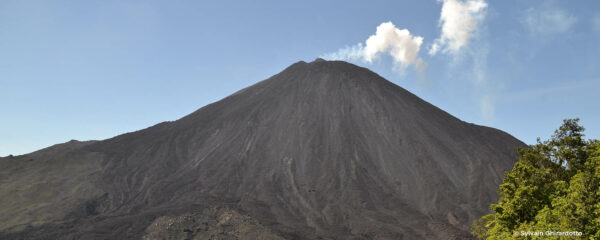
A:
[[0, 60, 525, 239]]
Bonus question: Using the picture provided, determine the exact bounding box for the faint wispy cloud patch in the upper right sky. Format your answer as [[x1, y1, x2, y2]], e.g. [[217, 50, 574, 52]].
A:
[[521, 2, 577, 37]]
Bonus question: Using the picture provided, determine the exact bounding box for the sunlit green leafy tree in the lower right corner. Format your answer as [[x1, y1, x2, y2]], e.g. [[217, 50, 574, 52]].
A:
[[473, 119, 600, 240]]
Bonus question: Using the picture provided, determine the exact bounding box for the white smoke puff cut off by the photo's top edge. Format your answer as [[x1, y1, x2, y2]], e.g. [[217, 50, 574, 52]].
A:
[[429, 0, 487, 55]]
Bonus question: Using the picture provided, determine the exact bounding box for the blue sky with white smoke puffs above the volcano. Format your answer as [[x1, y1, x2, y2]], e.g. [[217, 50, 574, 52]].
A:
[[0, 0, 600, 156]]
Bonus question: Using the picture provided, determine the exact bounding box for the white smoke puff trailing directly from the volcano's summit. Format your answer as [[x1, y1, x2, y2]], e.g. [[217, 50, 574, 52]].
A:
[[322, 22, 427, 73]]
